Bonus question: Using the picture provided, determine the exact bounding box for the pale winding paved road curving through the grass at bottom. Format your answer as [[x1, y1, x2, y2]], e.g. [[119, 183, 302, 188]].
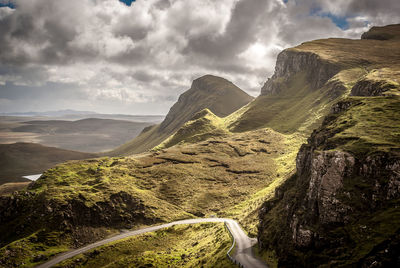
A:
[[36, 218, 268, 268]]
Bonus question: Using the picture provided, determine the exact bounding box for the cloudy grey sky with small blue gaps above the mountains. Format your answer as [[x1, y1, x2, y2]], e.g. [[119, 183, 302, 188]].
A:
[[0, 0, 400, 114]]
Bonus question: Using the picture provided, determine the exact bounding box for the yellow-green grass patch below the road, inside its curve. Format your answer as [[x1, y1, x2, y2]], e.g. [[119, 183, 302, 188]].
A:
[[56, 223, 235, 267]]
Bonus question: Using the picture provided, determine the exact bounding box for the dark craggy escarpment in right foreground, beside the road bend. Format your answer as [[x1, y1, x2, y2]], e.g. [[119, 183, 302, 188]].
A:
[[259, 97, 400, 267]]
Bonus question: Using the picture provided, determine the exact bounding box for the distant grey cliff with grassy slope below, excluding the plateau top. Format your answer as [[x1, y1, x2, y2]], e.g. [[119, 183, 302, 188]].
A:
[[228, 47, 350, 135]]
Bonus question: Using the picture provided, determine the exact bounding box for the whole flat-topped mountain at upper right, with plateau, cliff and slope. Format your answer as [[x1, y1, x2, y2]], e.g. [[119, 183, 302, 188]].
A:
[[229, 25, 400, 135]]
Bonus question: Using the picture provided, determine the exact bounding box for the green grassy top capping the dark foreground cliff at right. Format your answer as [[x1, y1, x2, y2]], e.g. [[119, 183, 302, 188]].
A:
[[322, 96, 400, 157]]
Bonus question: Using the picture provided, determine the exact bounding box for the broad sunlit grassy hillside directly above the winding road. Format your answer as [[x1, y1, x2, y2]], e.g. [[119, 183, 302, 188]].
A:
[[0, 127, 300, 264]]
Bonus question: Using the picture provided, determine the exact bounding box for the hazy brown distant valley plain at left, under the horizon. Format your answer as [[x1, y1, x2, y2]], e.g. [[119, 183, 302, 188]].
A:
[[0, 114, 163, 187]]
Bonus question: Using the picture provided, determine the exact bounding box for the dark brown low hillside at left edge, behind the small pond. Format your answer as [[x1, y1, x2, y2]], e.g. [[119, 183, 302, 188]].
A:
[[0, 143, 96, 184]]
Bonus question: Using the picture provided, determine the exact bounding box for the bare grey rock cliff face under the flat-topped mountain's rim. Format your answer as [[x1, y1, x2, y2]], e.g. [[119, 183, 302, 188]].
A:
[[261, 49, 340, 95]]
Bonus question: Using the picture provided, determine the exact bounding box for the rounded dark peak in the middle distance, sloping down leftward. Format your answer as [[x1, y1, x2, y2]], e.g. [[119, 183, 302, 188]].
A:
[[108, 75, 253, 155]]
